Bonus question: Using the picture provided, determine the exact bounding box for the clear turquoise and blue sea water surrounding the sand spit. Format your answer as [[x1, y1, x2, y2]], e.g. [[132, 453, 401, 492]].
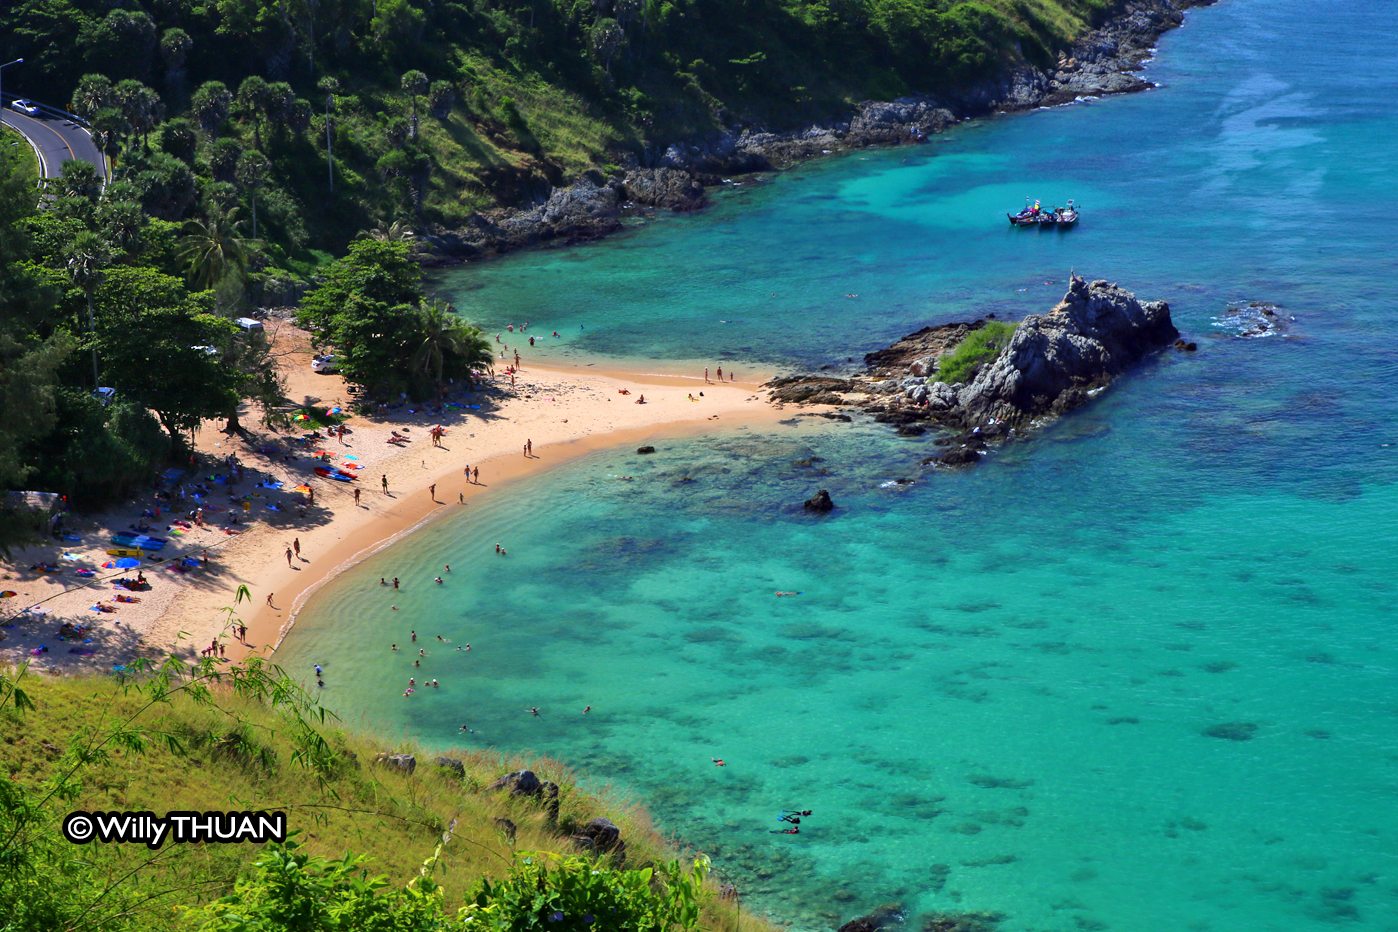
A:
[[280, 0, 1398, 929]]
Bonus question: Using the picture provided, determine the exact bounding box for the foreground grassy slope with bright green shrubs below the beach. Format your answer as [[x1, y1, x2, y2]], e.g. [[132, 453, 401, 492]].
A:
[[0, 595, 768, 932]]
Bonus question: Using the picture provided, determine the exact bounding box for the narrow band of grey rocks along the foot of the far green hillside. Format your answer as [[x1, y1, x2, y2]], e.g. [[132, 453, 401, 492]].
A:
[[419, 0, 1215, 264]]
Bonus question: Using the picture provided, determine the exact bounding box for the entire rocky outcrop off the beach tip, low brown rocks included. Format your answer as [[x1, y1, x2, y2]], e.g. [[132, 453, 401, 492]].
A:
[[766, 275, 1194, 465]]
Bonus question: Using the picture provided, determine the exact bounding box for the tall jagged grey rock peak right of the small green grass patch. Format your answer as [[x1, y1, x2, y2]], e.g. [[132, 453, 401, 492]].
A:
[[956, 275, 1180, 423]]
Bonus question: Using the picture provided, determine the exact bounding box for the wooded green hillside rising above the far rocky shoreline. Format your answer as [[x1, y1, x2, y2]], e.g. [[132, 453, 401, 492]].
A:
[[0, 0, 1113, 264]]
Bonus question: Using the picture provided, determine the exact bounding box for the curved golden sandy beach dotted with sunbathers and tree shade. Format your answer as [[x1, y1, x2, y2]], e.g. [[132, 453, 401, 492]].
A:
[[0, 323, 787, 672]]
